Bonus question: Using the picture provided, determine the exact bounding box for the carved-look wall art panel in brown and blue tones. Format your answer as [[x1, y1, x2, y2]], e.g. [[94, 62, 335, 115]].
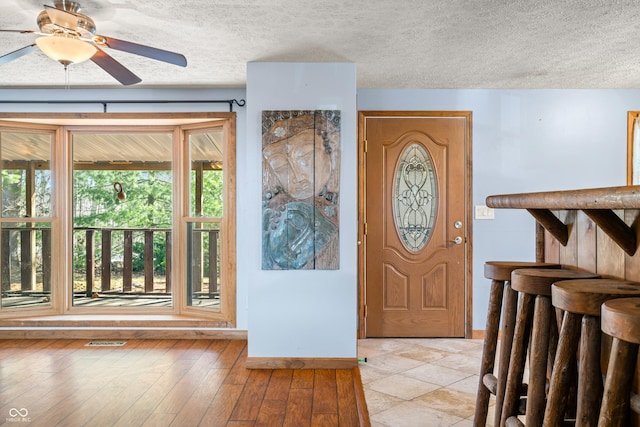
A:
[[262, 110, 340, 270]]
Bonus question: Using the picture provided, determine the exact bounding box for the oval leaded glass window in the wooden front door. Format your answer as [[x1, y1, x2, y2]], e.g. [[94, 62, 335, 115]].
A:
[[393, 143, 438, 252]]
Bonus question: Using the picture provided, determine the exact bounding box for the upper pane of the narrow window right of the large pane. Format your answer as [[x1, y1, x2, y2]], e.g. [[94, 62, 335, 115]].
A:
[[189, 129, 224, 218]]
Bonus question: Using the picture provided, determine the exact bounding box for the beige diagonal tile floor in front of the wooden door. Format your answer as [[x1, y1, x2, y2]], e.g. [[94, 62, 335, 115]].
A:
[[358, 338, 493, 427]]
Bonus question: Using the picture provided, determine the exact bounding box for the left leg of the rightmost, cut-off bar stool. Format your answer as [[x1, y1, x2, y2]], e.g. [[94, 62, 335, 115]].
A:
[[598, 337, 638, 427]]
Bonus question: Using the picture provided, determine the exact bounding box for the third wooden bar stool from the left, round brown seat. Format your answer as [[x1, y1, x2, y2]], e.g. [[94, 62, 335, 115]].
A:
[[544, 279, 640, 427]]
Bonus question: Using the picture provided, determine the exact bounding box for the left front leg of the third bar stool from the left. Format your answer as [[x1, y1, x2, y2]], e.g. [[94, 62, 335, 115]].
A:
[[543, 312, 582, 426]]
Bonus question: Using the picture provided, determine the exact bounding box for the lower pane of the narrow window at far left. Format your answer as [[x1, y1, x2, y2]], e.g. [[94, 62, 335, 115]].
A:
[[0, 223, 51, 308]]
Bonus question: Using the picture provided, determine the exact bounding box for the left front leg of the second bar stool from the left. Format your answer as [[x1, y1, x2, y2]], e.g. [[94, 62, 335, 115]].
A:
[[498, 293, 535, 426]]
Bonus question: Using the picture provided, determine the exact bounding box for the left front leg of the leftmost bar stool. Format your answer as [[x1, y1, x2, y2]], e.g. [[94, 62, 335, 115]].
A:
[[473, 280, 504, 427]]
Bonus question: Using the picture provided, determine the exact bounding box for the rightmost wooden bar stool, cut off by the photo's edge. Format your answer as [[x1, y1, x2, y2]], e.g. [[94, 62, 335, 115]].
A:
[[598, 298, 640, 427]]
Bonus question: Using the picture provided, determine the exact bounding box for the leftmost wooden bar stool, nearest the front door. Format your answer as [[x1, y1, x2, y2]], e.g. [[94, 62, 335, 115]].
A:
[[473, 261, 560, 427]]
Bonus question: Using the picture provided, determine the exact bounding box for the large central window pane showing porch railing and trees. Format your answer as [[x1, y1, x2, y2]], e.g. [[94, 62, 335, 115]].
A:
[[73, 133, 173, 307]]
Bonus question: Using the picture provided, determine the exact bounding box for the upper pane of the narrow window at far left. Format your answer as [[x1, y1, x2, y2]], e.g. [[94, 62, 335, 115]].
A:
[[0, 131, 52, 218]]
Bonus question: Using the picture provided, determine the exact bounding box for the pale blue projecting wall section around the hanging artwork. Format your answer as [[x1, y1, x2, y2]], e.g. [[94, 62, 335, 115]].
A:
[[244, 62, 357, 358]]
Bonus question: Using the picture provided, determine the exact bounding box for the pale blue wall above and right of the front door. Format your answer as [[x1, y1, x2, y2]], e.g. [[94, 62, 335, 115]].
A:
[[358, 89, 640, 329]]
